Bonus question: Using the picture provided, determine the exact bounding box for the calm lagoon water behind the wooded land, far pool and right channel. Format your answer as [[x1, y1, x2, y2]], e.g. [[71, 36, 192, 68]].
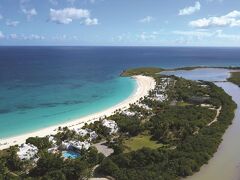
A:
[[164, 68, 240, 180]]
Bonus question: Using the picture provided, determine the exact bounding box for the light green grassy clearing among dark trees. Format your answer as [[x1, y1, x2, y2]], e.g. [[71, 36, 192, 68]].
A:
[[123, 135, 163, 153]]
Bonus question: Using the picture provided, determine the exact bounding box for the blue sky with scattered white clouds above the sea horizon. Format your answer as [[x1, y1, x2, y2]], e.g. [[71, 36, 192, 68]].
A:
[[0, 0, 240, 46]]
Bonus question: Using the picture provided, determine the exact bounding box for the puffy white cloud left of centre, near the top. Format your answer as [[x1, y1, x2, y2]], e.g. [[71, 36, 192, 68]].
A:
[[50, 8, 98, 25]]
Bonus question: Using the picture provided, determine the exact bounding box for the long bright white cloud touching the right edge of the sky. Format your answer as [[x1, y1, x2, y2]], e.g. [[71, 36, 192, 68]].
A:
[[189, 11, 240, 28]]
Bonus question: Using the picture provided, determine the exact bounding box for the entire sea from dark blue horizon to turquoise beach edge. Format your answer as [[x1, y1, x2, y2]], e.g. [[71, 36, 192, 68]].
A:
[[0, 47, 240, 138]]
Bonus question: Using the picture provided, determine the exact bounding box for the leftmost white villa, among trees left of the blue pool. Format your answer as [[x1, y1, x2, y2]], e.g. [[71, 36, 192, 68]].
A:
[[17, 144, 38, 160]]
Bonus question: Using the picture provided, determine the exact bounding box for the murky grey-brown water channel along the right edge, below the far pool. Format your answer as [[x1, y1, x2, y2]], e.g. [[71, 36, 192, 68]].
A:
[[187, 82, 240, 180]]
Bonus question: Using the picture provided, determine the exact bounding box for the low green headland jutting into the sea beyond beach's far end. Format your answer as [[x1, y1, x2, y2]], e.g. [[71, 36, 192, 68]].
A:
[[121, 67, 163, 76]]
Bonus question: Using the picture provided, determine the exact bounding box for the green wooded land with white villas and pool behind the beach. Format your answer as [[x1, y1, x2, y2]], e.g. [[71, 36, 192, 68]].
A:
[[0, 67, 237, 180]]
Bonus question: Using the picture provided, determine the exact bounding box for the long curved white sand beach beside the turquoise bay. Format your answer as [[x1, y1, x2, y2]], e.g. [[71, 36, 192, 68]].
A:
[[0, 75, 156, 149]]
